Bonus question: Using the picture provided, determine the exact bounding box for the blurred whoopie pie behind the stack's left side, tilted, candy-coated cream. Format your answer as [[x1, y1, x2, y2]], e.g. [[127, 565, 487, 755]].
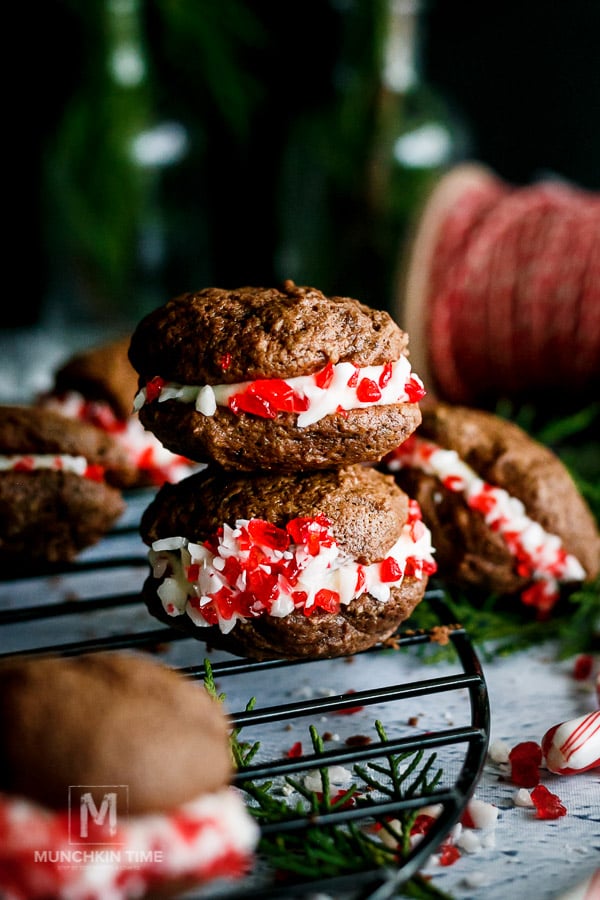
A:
[[38, 335, 195, 488]]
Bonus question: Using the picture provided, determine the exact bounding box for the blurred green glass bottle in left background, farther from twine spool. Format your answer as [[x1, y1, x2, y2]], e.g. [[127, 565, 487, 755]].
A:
[[44, 0, 188, 324]]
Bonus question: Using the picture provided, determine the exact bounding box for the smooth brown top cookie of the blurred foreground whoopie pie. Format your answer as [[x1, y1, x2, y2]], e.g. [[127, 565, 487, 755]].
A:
[[0, 653, 231, 813]]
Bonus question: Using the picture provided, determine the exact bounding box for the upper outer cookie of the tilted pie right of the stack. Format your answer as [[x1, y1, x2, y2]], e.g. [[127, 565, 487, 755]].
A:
[[419, 403, 600, 577]]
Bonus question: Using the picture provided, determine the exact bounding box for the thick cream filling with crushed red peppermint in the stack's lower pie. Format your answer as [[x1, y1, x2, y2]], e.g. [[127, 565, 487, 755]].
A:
[[149, 501, 436, 634]]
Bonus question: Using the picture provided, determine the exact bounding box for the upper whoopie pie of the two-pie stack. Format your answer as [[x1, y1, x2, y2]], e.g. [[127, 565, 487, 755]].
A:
[[129, 281, 424, 472]]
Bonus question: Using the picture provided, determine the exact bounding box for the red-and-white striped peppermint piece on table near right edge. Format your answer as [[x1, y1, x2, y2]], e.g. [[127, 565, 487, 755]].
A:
[[542, 710, 600, 775]]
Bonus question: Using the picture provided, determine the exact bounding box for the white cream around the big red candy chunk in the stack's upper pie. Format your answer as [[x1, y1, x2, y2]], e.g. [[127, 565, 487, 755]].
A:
[[133, 356, 424, 428]]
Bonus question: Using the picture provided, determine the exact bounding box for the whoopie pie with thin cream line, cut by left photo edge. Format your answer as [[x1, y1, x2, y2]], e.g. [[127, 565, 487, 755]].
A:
[[0, 406, 135, 569]]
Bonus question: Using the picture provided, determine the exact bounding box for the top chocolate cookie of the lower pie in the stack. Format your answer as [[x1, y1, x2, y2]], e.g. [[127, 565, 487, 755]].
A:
[[140, 465, 408, 563]]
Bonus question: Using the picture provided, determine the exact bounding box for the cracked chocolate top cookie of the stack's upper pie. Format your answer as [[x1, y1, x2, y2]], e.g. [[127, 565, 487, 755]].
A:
[[129, 281, 408, 384]]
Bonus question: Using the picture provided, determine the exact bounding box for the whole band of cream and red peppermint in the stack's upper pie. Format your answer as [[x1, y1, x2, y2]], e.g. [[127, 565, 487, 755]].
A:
[[133, 356, 425, 428]]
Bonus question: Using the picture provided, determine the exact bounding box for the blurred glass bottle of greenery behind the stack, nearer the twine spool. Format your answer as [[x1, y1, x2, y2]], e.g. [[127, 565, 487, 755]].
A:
[[278, 0, 465, 309]]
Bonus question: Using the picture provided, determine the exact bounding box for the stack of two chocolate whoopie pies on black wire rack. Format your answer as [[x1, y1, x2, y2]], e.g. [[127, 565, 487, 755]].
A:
[[129, 281, 436, 659]]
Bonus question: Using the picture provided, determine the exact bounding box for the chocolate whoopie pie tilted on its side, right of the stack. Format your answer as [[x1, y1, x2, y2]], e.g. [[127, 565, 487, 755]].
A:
[[382, 403, 600, 613]]
